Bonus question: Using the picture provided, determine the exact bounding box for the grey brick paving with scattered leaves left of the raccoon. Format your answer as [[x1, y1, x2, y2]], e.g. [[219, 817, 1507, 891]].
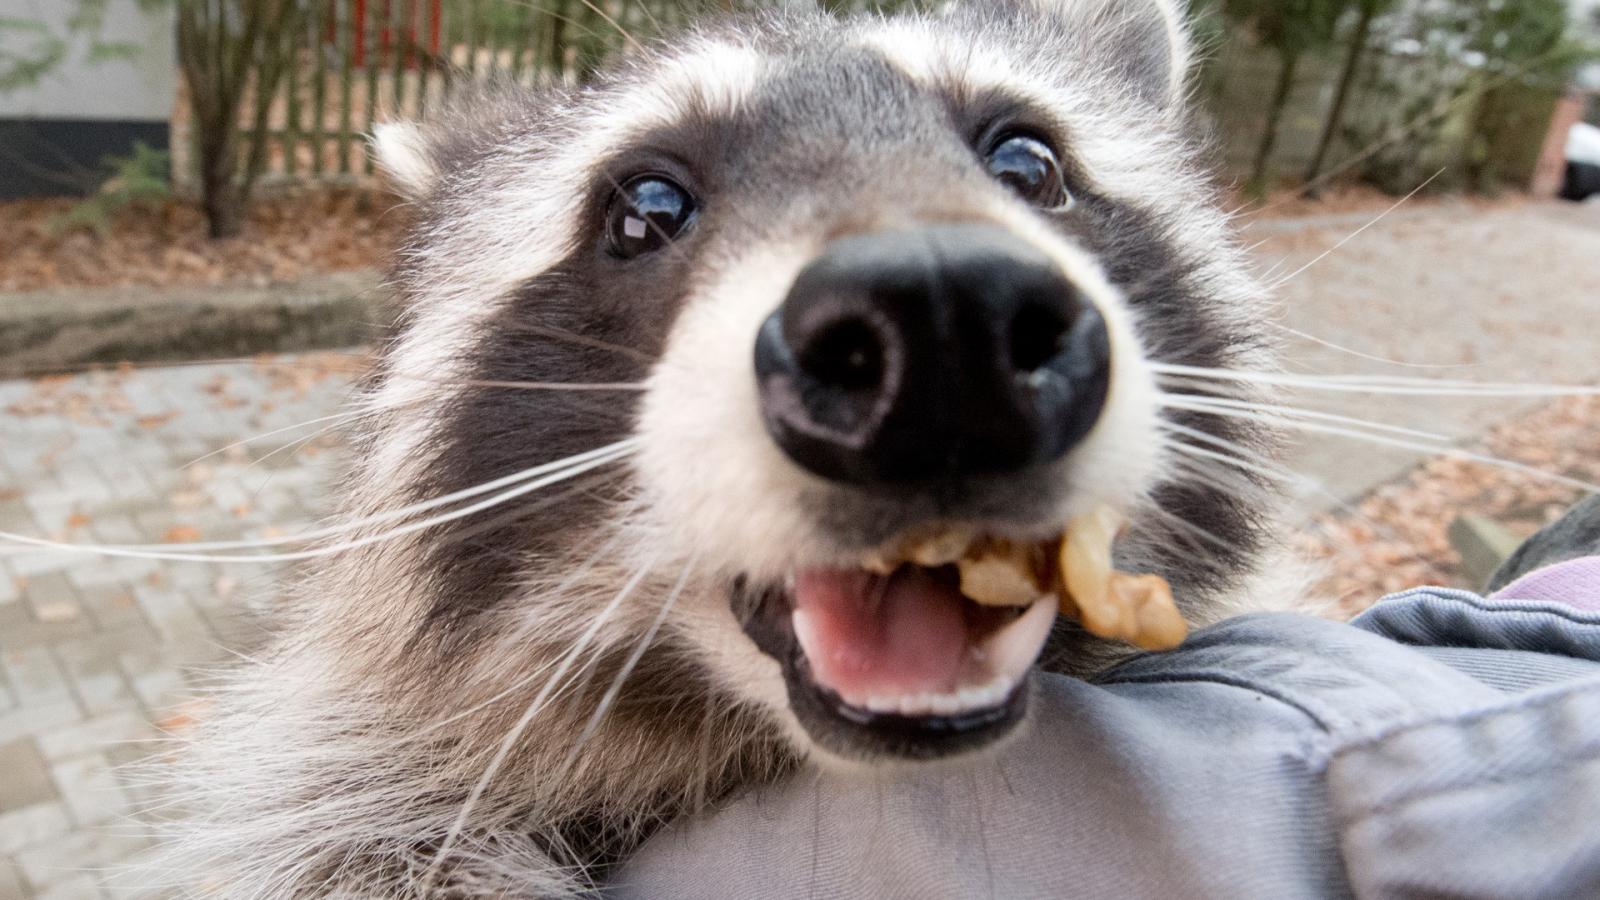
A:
[[0, 356, 352, 900]]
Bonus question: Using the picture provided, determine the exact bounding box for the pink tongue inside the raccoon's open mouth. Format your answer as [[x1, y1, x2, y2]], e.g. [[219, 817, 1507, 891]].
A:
[[792, 569, 970, 705]]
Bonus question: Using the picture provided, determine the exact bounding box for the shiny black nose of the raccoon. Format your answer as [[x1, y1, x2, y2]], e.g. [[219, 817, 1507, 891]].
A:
[[755, 224, 1110, 484]]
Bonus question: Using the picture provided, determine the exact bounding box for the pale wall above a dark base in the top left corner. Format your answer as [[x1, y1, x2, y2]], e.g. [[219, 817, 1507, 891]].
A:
[[0, 0, 178, 122]]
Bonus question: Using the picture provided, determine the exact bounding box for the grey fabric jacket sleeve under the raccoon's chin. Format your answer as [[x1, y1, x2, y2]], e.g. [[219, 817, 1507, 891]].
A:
[[611, 589, 1600, 900]]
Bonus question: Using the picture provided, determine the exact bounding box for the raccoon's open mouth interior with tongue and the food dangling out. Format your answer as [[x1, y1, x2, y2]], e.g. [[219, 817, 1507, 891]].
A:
[[787, 508, 1187, 721]]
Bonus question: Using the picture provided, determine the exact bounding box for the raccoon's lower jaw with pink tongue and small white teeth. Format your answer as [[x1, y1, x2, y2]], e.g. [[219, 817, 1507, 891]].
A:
[[733, 565, 1056, 761]]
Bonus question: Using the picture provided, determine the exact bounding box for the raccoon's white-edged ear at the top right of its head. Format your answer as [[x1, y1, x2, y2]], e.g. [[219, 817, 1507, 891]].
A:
[[1024, 0, 1194, 109]]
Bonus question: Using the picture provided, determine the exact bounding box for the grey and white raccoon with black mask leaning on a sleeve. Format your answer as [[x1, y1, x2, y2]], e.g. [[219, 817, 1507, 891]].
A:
[[168, 0, 1274, 898]]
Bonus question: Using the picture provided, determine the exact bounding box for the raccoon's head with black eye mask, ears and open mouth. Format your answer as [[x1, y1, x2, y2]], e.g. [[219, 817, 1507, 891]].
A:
[[374, 0, 1261, 759]]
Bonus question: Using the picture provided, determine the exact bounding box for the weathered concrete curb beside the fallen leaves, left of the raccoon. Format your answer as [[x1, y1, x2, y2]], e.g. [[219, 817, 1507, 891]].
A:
[[0, 271, 384, 378]]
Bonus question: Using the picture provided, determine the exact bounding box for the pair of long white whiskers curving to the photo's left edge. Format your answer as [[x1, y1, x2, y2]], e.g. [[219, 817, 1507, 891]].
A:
[[0, 439, 634, 562]]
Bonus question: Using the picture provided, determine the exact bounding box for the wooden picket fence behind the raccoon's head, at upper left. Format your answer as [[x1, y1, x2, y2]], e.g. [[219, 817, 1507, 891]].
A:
[[173, 0, 910, 191]]
